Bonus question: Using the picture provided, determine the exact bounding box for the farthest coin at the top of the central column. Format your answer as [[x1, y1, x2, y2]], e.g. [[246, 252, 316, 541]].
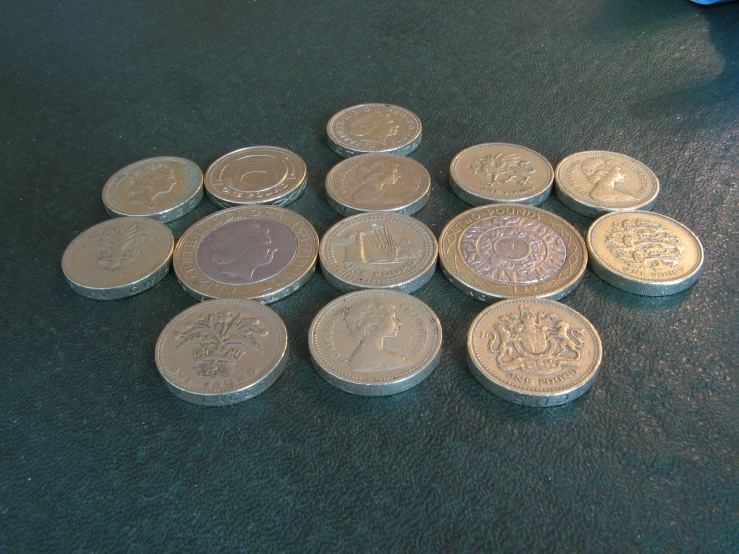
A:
[[326, 104, 421, 158]]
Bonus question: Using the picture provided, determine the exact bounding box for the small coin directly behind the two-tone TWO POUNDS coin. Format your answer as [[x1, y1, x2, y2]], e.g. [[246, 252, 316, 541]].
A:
[[449, 142, 554, 206]]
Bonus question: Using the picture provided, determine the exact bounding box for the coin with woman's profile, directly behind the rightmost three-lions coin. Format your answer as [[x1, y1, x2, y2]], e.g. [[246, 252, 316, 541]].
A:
[[555, 151, 659, 217]]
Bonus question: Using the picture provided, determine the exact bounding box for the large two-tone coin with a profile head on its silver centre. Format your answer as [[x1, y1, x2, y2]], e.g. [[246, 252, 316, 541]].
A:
[[174, 206, 318, 304]]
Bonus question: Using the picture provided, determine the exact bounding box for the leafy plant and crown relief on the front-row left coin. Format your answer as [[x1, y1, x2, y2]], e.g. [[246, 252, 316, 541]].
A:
[[175, 310, 268, 379]]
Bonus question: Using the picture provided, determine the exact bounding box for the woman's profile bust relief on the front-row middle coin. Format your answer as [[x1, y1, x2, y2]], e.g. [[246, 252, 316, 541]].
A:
[[344, 300, 410, 371]]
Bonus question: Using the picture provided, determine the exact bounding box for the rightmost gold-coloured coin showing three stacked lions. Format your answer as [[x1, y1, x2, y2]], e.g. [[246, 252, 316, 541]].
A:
[[585, 212, 704, 296]]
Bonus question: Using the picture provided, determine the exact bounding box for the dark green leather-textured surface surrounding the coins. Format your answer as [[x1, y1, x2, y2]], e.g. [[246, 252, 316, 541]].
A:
[[0, 0, 739, 553]]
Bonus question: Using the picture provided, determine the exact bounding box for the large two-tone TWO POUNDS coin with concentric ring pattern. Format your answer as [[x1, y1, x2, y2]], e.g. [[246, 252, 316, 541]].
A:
[[439, 204, 588, 302]]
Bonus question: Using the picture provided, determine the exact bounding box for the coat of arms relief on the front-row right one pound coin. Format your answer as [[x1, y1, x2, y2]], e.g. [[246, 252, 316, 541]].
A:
[[483, 305, 583, 375]]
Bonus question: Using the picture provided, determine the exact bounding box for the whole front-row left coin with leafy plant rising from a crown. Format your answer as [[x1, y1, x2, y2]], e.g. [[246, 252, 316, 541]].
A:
[[156, 298, 287, 406]]
